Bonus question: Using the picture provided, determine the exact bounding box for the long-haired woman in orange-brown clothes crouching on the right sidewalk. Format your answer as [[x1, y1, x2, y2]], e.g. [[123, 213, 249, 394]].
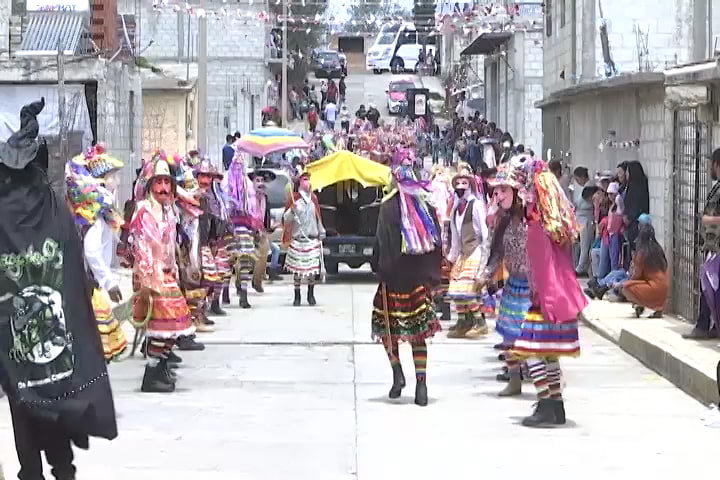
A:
[[622, 222, 670, 318]]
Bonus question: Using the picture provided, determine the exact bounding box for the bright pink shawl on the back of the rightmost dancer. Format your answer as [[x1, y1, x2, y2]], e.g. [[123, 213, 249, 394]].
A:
[[527, 220, 588, 323]]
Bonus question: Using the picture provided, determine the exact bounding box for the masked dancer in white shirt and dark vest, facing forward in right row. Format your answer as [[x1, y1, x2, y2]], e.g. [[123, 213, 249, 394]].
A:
[[447, 164, 489, 338]]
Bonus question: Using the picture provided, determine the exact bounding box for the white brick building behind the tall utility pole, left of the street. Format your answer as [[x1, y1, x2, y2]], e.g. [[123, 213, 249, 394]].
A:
[[139, 0, 272, 162]]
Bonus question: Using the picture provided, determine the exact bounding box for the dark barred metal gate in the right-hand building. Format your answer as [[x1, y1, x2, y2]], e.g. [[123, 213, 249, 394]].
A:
[[672, 108, 712, 321]]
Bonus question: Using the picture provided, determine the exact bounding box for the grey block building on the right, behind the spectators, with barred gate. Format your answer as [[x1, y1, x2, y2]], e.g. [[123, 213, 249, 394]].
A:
[[536, 0, 720, 319]]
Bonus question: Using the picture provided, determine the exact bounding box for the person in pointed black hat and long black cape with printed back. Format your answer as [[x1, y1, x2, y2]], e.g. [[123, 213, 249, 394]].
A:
[[0, 99, 117, 480]]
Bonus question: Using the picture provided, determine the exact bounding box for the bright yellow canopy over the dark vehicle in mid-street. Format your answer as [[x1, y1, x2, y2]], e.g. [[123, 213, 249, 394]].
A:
[[306, 150, 390, 190]]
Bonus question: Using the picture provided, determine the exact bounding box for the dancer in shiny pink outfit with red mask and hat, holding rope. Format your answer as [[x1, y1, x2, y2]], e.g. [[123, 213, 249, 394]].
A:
[[130, 152, 195, 392]]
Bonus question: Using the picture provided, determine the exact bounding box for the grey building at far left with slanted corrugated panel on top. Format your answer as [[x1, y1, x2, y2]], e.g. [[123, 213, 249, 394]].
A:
[[0, 0, 142, 201]]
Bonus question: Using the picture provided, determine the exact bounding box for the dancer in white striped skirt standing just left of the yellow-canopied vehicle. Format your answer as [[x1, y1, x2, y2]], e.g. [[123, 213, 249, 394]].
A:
[[283, 173, 325, 307]]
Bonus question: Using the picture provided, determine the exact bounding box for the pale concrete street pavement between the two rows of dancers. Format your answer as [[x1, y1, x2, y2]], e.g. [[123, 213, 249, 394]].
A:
[[0, 272, 717, 480]]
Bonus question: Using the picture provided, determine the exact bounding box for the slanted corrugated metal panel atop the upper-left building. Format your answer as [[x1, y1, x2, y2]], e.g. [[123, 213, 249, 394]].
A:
[[18, 12, 88, 55]]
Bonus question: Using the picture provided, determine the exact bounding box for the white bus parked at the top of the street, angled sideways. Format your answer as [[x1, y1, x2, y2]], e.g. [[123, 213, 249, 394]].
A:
[[365, 23, 435, 74]]
